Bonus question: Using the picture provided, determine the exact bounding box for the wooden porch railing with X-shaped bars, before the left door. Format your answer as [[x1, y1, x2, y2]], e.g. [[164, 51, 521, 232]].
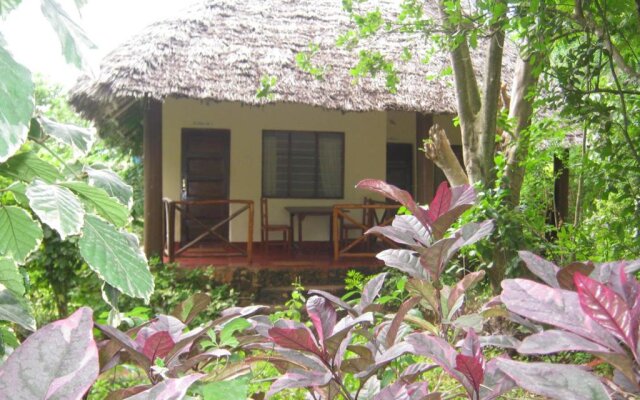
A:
[[162, 198, 254, 263]]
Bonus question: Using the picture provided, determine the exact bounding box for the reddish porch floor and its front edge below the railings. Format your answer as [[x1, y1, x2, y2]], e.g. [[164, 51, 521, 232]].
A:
[[164, 242, 384, 304]]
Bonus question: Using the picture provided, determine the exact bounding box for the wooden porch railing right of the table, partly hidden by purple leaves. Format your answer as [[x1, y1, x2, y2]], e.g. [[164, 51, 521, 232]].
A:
[[332, 204, 399, 261]]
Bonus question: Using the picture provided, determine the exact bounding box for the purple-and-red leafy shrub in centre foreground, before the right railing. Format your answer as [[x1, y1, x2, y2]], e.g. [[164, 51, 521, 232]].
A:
[[240, 180, 500, 399]]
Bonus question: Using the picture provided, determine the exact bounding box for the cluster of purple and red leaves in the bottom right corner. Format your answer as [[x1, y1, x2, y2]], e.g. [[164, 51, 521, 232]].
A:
[[500, 252, 640, 399]]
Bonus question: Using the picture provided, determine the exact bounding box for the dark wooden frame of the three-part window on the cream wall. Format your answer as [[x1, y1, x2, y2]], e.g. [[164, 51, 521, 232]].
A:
[[260, 129, 345, 200]]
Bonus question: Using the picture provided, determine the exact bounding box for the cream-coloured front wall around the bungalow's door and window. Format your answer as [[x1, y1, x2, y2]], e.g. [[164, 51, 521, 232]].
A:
[[162, 99, 388, 242]]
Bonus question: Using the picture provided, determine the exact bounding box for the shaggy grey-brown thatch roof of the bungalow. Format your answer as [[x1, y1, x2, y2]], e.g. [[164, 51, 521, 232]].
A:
[[71, 0, 511, 121]]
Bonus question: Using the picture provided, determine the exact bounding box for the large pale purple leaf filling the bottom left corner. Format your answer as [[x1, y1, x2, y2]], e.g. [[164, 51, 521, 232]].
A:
[[0, 307, 100, 400]]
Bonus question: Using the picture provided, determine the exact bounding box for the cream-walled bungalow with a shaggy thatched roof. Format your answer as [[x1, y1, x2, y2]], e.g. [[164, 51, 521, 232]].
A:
[[71, 0, 510, 252]]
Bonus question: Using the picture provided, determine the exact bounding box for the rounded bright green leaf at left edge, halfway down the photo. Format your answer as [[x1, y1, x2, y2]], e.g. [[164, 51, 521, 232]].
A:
[[0, 206, 42, 264]]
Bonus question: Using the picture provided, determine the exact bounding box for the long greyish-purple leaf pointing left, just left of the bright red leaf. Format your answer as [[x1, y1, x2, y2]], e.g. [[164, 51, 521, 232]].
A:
[[500, 279, 622, 352]]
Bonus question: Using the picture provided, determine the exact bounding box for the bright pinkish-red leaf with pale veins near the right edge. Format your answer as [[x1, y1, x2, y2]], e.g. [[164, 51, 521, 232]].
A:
[[573, 273, 638, 353]]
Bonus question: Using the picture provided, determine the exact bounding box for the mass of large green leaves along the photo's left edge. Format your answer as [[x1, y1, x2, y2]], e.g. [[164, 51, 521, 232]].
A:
[[0, 0, 153, 353]]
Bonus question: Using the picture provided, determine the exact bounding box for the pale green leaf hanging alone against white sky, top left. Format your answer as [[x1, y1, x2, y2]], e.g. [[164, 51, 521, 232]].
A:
[[40, 0, 95, 68]]
